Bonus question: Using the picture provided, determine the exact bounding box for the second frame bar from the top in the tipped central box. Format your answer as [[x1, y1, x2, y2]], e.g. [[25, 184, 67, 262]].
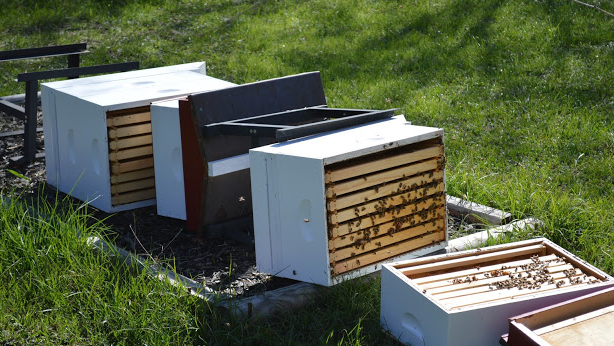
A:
[[326, 159, 440, 198]]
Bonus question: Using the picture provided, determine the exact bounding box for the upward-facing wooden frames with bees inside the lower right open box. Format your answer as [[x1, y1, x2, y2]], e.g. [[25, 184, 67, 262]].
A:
[[397, 239, 607, 309]]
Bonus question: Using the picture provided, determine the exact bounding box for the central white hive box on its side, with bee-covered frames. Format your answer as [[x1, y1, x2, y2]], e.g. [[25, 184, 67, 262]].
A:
[[250, 116, 447, 286]]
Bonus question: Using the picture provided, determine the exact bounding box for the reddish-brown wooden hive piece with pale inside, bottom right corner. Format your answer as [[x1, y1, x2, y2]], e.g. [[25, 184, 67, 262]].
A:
[[501, 287, 614, 346]]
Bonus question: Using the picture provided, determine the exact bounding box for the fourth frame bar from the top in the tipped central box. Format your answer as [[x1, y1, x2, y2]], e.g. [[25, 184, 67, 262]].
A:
[[328, 181, 445, 224]]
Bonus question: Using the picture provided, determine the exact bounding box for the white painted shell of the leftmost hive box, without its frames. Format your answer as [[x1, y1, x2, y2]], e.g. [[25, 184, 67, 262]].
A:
[[41, 62, 234, 212]]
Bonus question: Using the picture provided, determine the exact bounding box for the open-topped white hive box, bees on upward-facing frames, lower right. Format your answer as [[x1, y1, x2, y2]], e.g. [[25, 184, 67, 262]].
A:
[[381, 238, 612, 346]]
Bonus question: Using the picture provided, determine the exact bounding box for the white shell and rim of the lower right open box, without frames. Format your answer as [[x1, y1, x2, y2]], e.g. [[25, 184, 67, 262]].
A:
[[380, 239, 612, 346]]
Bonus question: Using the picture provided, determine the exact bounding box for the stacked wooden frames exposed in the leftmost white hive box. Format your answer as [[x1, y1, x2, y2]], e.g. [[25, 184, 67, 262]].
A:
[[107, 106, 156, 206]]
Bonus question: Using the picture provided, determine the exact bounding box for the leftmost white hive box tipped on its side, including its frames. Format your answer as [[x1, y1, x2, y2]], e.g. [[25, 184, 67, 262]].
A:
[[41, 62, 233, 212]]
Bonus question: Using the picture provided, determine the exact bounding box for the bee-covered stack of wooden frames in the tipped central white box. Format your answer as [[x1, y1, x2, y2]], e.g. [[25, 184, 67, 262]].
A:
[[325, 138, 446, 276]]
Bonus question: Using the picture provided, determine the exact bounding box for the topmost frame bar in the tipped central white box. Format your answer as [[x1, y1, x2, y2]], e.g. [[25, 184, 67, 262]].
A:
[[326, 145, 443, 184]]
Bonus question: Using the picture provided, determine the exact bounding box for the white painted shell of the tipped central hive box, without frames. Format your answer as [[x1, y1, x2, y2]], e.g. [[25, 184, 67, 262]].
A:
[[249, 116, 446, 286]]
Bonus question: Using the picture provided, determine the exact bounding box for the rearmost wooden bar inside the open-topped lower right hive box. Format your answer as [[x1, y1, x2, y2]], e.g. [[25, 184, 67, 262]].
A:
[[402, 244, 546, 278]]
